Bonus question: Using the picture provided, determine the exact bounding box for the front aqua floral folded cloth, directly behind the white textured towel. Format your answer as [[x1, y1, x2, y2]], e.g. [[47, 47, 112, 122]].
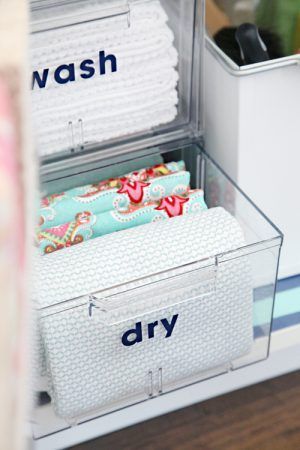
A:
[[37, 190, 207, 254]]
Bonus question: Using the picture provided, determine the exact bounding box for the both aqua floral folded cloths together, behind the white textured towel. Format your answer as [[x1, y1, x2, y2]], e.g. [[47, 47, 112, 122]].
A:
[[36, 161, 207, 254]]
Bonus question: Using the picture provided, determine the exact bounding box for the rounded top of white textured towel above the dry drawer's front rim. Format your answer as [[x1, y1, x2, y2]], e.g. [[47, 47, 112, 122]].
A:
[[33, 207, 250, 308]]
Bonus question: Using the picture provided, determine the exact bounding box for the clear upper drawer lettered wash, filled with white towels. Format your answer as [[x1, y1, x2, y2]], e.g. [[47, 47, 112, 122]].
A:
[[30, 0, 203, 162]]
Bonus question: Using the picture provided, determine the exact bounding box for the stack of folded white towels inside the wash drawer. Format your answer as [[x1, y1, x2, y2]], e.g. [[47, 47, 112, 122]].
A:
[[31, 0, 178, 156]]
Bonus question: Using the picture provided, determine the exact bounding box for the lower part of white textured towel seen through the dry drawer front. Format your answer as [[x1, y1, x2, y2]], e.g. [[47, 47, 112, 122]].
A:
[[41, 259, 253, 421]]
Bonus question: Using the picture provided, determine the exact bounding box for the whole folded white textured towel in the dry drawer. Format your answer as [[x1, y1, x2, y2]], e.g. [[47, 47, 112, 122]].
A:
[[34, 208, 253, 419]]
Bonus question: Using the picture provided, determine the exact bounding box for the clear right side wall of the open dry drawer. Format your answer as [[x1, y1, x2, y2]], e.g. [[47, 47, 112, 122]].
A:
[[202, 149, 282, 368]]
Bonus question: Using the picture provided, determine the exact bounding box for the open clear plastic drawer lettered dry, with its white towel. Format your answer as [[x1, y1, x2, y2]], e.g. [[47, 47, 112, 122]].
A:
[[34, 146, 282, 437]]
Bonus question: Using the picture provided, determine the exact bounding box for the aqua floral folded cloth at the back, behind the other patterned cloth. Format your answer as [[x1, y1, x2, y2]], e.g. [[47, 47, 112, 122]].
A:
[[39, 161, 190, 230]]
